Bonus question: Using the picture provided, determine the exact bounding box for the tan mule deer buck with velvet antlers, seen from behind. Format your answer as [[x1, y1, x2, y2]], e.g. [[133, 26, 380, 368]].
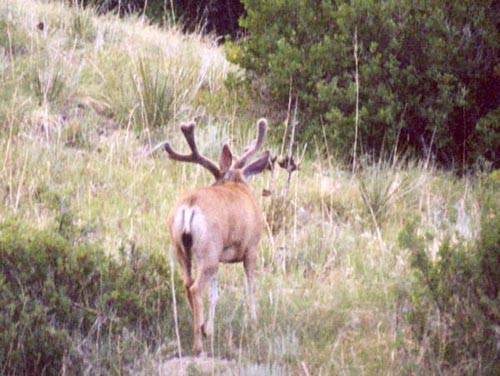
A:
[[164, 119, 272, 355]]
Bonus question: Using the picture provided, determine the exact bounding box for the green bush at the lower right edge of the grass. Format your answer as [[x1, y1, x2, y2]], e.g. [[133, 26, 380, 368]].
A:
[[399, 171, 500, 375]]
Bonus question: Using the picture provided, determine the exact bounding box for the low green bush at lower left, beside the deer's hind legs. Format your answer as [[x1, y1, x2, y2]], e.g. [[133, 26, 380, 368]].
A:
[[0, 221, 180, 375]]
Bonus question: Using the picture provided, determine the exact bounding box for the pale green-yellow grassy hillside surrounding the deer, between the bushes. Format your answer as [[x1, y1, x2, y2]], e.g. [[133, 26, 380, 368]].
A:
[[0, 0, 496, 375]]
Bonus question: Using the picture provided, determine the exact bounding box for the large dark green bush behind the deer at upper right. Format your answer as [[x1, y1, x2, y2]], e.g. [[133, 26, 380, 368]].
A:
[[235, 0, 500, 166]]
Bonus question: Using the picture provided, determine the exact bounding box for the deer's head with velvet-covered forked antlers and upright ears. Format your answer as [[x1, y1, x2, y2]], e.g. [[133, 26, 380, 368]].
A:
[[164, 119, 276, 184]]
